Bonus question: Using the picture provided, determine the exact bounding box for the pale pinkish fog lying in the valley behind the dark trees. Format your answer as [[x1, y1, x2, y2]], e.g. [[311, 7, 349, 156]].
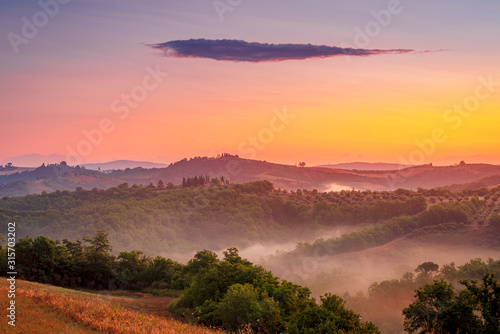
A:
[[162, 227, 500, 334]]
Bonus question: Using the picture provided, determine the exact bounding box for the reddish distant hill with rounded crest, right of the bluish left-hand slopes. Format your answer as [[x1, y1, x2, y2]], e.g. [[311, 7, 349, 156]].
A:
[[80, 154, 500, 191]]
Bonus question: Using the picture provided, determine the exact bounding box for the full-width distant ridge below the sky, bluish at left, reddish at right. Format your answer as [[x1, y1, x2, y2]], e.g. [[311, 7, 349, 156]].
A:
[[0, 154, 500, 197]]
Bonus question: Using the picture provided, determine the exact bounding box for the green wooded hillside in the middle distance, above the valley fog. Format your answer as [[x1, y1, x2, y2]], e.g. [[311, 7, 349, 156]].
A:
[[0, 181, 427, 254]]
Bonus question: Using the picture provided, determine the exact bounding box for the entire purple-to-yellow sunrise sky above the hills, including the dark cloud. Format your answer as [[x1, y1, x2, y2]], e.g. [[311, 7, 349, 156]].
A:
[[0, 0, 500, 166]]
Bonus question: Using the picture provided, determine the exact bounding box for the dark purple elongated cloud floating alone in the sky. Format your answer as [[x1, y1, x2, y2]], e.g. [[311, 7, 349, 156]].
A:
[[149, 39, 414, 62]]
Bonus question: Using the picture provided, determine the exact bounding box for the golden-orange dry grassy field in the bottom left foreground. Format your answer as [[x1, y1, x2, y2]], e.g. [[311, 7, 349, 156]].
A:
[[0, 279, 222, 334]]
